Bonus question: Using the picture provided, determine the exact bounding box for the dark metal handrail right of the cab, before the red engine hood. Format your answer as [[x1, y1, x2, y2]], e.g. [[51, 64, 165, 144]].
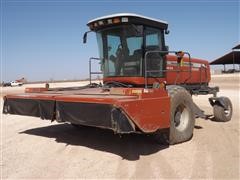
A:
[[144, 50, 192, 89]]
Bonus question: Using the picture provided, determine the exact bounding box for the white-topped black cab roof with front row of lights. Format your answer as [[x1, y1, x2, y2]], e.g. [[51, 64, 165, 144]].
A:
[[87, 13, 168, 31]]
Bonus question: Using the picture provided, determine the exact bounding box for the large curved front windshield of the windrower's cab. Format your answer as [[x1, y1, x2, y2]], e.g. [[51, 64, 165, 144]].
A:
[[97, 25, 143, 77]]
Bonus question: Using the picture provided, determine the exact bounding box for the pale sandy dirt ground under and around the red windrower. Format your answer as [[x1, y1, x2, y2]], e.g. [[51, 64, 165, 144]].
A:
[[1, 75, 240, 179]]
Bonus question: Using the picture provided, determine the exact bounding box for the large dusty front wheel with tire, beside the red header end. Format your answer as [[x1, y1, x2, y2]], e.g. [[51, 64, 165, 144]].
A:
[[167, 85, 195, 144]]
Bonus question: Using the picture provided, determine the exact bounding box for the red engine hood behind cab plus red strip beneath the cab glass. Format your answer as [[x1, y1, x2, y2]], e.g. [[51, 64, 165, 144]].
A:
[[103, 55, 210, 85]]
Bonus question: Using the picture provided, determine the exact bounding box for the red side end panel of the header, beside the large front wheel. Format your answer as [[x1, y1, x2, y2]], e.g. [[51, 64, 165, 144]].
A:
[[120, 89, 170, 132]]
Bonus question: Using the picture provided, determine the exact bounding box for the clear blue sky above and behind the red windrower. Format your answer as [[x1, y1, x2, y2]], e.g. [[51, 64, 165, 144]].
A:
[[0, 0, 240, 81]]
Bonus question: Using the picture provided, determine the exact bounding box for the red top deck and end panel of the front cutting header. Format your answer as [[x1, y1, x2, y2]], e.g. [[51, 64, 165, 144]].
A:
[[5, 88, 170, 132]]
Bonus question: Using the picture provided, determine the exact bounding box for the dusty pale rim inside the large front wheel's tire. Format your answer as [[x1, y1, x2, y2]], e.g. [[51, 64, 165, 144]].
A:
[[174, 104, 190, 131]]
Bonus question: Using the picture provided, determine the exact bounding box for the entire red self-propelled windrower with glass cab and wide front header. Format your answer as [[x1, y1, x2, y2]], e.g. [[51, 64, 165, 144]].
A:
[[3, 13, 232, 144]]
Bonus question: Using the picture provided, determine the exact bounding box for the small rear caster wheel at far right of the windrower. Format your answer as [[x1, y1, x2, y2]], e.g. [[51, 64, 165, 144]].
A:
[[213, 97, 232, 122]]
